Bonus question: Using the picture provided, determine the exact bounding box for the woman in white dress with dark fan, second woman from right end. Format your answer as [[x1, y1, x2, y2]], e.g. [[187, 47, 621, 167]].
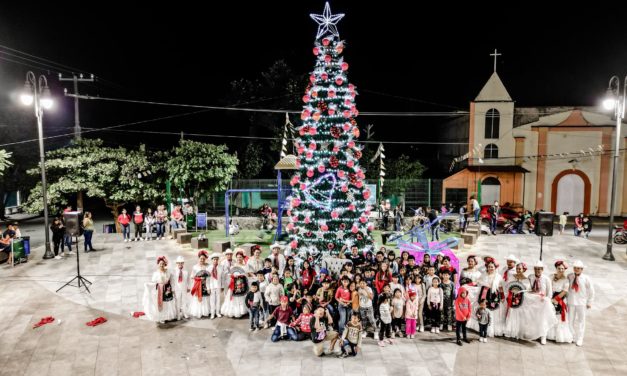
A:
[[503, 262, 531, 339]]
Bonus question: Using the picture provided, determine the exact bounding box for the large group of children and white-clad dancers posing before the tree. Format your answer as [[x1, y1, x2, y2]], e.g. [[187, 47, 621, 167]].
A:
[[144, 244, 594, 357]]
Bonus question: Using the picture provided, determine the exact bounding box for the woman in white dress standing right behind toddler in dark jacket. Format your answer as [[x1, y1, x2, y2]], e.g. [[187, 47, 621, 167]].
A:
[[467, 256, 505, 337]]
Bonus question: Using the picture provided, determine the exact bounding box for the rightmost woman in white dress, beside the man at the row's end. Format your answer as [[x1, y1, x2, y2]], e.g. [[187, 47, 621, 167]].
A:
[[547, 260, 573, 343]]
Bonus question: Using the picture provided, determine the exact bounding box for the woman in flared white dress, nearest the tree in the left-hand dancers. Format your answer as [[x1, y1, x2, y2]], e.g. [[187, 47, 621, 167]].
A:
[[220, 249, 248, 317]]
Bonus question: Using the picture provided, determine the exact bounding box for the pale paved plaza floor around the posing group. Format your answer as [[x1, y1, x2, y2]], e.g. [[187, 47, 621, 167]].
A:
[[0, 234, 627, 376]]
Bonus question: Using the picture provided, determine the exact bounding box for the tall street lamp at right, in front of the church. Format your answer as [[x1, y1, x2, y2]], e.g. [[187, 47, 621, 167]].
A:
[[603, 76, 627, 261]]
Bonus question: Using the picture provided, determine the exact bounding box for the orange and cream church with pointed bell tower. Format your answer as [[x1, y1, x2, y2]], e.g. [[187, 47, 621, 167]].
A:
[[442, 72, 627, 216]]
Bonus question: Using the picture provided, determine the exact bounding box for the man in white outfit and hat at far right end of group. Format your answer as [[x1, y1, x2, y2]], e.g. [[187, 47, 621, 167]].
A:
[[568, 260, 594, 346]]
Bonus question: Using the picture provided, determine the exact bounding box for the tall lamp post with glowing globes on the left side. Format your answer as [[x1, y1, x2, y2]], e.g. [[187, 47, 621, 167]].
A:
[[20, 71, 54, 259]]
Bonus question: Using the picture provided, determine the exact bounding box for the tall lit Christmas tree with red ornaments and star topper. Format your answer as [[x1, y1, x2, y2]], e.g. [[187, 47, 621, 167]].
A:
[[287, 3, 374, 257]]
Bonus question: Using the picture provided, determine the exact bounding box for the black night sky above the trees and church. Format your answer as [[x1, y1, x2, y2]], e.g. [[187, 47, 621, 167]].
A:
[[0, 0, 627, 173]]
